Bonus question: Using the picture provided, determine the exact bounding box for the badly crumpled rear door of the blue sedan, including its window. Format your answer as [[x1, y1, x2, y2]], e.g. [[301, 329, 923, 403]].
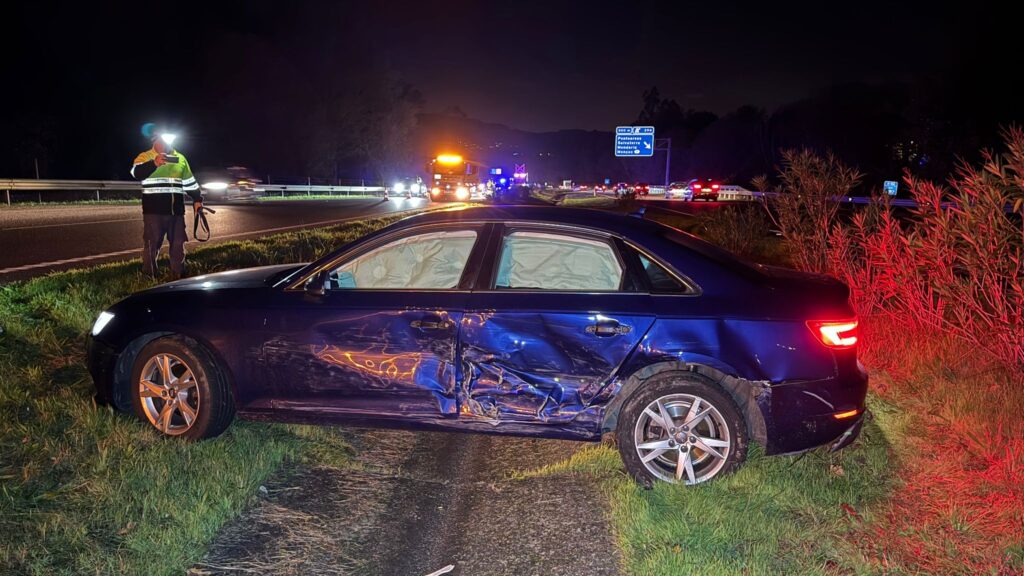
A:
[[459, 223, 654, 425]]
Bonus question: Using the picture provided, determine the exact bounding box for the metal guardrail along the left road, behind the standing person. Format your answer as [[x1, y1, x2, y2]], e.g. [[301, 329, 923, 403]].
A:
[[0, 178, 384, 206]]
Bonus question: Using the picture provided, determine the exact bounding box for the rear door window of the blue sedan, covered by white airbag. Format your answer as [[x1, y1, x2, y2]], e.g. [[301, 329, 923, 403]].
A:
[[495, 232, 623, 292]]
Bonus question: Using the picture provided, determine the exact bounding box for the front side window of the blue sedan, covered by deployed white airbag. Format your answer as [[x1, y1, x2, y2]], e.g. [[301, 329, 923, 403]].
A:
[[328, 230, 476, 290]]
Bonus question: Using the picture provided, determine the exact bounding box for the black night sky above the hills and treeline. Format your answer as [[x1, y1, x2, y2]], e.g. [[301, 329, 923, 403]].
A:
[[0, 1, 1007, 177]]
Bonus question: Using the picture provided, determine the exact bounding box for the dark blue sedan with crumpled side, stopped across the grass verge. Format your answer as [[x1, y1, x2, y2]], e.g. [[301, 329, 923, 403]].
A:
[[89, 207, 867, 484]]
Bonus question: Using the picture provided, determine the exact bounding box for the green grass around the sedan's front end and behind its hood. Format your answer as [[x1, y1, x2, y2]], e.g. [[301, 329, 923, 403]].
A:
[[0, 211, 415, 574]]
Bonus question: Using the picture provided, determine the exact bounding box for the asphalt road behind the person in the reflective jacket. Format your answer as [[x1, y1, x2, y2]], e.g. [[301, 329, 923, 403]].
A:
[[0, 198, 428, 283]]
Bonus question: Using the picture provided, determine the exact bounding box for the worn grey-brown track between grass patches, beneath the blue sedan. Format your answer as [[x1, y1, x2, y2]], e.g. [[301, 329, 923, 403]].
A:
[[191, 430, 620, 575]]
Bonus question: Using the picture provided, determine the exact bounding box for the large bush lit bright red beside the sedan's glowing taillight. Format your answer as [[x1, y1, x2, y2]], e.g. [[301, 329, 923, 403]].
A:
[[827, 129, 1024, 370]]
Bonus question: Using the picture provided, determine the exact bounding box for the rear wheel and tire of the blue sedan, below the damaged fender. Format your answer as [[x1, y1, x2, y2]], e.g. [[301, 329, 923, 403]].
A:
[[615, 372, 750, 486]]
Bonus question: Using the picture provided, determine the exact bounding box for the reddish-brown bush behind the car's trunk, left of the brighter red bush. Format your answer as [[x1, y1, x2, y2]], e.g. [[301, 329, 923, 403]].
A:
[[754, 150, 861, 273]]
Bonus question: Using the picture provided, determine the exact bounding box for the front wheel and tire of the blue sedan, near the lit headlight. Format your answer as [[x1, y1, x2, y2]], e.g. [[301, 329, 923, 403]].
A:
[[129, 335, 234, 440]]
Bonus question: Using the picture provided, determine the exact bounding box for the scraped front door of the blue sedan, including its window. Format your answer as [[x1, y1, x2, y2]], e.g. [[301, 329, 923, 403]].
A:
[[262, 224, 483, 419]]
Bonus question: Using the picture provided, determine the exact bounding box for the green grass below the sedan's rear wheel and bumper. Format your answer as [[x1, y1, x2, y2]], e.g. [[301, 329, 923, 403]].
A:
[[527, 397, 906, 576]]
